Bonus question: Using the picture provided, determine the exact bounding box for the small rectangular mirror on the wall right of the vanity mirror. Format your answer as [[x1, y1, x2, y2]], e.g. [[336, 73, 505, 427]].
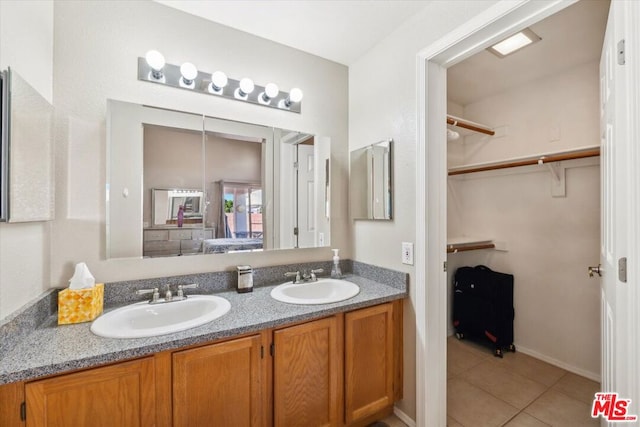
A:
[[349, 139, 393, 220]]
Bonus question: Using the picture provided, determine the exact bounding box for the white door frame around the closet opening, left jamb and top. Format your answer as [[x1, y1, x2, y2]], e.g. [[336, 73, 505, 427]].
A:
[[415, 0, 577, 426]]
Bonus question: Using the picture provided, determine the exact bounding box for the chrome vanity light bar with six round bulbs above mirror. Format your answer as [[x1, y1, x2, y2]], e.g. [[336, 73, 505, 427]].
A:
[[138, 58, 302, 114]]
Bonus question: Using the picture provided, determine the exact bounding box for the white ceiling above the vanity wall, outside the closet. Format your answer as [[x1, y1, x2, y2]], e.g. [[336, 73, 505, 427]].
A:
[[156, 0, 430, 65]]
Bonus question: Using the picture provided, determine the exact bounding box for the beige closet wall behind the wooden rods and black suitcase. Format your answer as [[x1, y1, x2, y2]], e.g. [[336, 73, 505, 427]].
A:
[[448, 62, 600, 379]]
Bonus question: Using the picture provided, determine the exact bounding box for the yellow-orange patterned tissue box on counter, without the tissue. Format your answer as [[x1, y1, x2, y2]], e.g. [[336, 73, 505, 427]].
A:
[[58, 283, 104, 325]]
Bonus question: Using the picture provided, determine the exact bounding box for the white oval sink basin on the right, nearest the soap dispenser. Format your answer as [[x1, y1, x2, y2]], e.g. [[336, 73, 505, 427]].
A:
[[271, 279, 360, 304]]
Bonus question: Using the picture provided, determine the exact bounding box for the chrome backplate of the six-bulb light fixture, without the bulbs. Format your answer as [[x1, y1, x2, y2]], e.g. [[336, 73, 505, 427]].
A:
[[138, 58, 302, 114]]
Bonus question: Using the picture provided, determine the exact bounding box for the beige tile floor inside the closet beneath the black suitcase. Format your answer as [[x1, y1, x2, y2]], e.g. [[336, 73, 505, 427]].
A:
[[447, 337, 600, 427]]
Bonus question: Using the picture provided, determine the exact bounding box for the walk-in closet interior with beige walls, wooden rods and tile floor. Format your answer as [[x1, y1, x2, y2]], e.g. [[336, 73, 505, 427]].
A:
[[447, 0, 609, 426]]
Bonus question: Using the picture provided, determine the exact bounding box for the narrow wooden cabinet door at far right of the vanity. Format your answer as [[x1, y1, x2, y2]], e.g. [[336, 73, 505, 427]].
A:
[[344, 303, 394, 424]]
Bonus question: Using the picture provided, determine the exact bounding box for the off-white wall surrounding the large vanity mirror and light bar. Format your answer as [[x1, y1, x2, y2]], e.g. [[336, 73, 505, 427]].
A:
[[51, 1, 351, 286]]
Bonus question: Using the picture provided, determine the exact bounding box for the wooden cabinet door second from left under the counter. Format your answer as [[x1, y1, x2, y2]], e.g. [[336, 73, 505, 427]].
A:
[[173, 335, 265, 427]]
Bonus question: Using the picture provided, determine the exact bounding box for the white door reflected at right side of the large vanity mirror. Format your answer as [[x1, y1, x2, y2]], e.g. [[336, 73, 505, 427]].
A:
[[297, 144, 316, 248]]
